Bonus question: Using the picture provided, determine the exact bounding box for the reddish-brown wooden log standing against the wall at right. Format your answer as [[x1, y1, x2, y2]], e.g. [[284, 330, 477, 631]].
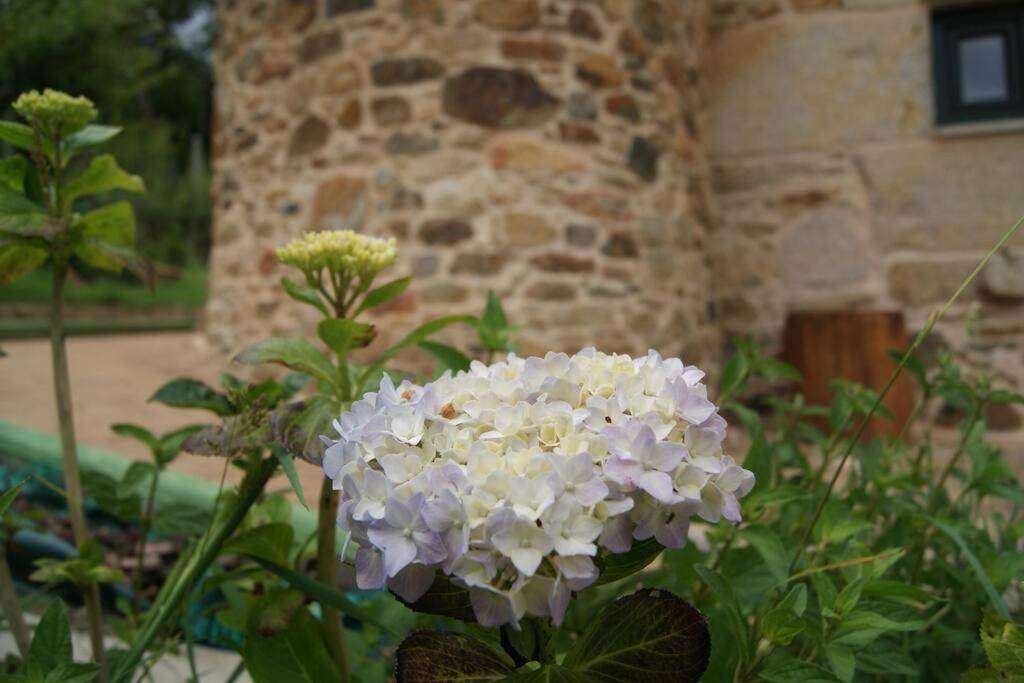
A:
[[782, 310, 914, 437]]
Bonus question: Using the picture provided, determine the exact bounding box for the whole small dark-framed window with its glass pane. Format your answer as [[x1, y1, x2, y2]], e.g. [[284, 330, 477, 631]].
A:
[[932, 3, 1024, 124]]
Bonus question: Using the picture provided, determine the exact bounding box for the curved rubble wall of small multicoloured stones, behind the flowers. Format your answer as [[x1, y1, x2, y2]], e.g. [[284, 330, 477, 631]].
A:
[[207, 0, 717, 368]]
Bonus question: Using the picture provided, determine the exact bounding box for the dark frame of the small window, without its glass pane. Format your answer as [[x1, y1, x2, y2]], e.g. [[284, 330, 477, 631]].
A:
[[932, 3, 1024, 125]]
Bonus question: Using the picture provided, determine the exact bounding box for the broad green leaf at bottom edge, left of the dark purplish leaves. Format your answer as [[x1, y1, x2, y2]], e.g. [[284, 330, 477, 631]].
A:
[[242, 609, 339, 683]]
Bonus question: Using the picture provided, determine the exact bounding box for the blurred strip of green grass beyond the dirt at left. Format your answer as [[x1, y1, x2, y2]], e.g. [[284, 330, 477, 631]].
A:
[[0, 266, 207, 308]]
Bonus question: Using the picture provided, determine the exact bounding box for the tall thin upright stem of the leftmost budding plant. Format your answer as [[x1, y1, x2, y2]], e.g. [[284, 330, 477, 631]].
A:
[[50, 259, 110, 683]]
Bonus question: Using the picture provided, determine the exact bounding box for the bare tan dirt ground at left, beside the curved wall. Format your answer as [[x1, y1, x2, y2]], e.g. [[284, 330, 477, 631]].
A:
[[0, 333, 323, 500]]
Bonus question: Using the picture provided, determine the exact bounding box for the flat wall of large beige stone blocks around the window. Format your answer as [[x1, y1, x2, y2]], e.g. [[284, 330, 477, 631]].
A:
[[708, 0, 1024, 427]]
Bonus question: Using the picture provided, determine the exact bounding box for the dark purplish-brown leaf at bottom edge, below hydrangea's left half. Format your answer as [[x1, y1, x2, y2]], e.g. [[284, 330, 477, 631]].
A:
[[395, 631, 512, 683]]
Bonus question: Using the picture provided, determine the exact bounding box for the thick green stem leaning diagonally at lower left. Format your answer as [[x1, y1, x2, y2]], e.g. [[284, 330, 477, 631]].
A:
[[114, 450, 278, 683]]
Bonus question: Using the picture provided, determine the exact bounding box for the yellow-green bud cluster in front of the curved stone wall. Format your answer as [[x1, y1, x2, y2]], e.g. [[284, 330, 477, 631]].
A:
[[276, 230, 398, 280]]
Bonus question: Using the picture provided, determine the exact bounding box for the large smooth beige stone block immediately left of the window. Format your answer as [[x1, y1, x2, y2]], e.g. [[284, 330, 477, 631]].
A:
[[706, 7, 932, 155]]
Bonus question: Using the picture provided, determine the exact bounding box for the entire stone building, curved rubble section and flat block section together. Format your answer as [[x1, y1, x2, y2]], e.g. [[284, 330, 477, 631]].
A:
[[207, 0, 1024, 419]]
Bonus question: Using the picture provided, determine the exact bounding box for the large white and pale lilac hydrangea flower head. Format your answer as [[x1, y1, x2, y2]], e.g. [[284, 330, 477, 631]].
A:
[[324, 348, 754, 626]]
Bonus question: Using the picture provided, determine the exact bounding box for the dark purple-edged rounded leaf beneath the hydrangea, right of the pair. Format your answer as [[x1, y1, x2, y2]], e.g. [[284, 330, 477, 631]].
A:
[[562, 589, 711, 683]]
